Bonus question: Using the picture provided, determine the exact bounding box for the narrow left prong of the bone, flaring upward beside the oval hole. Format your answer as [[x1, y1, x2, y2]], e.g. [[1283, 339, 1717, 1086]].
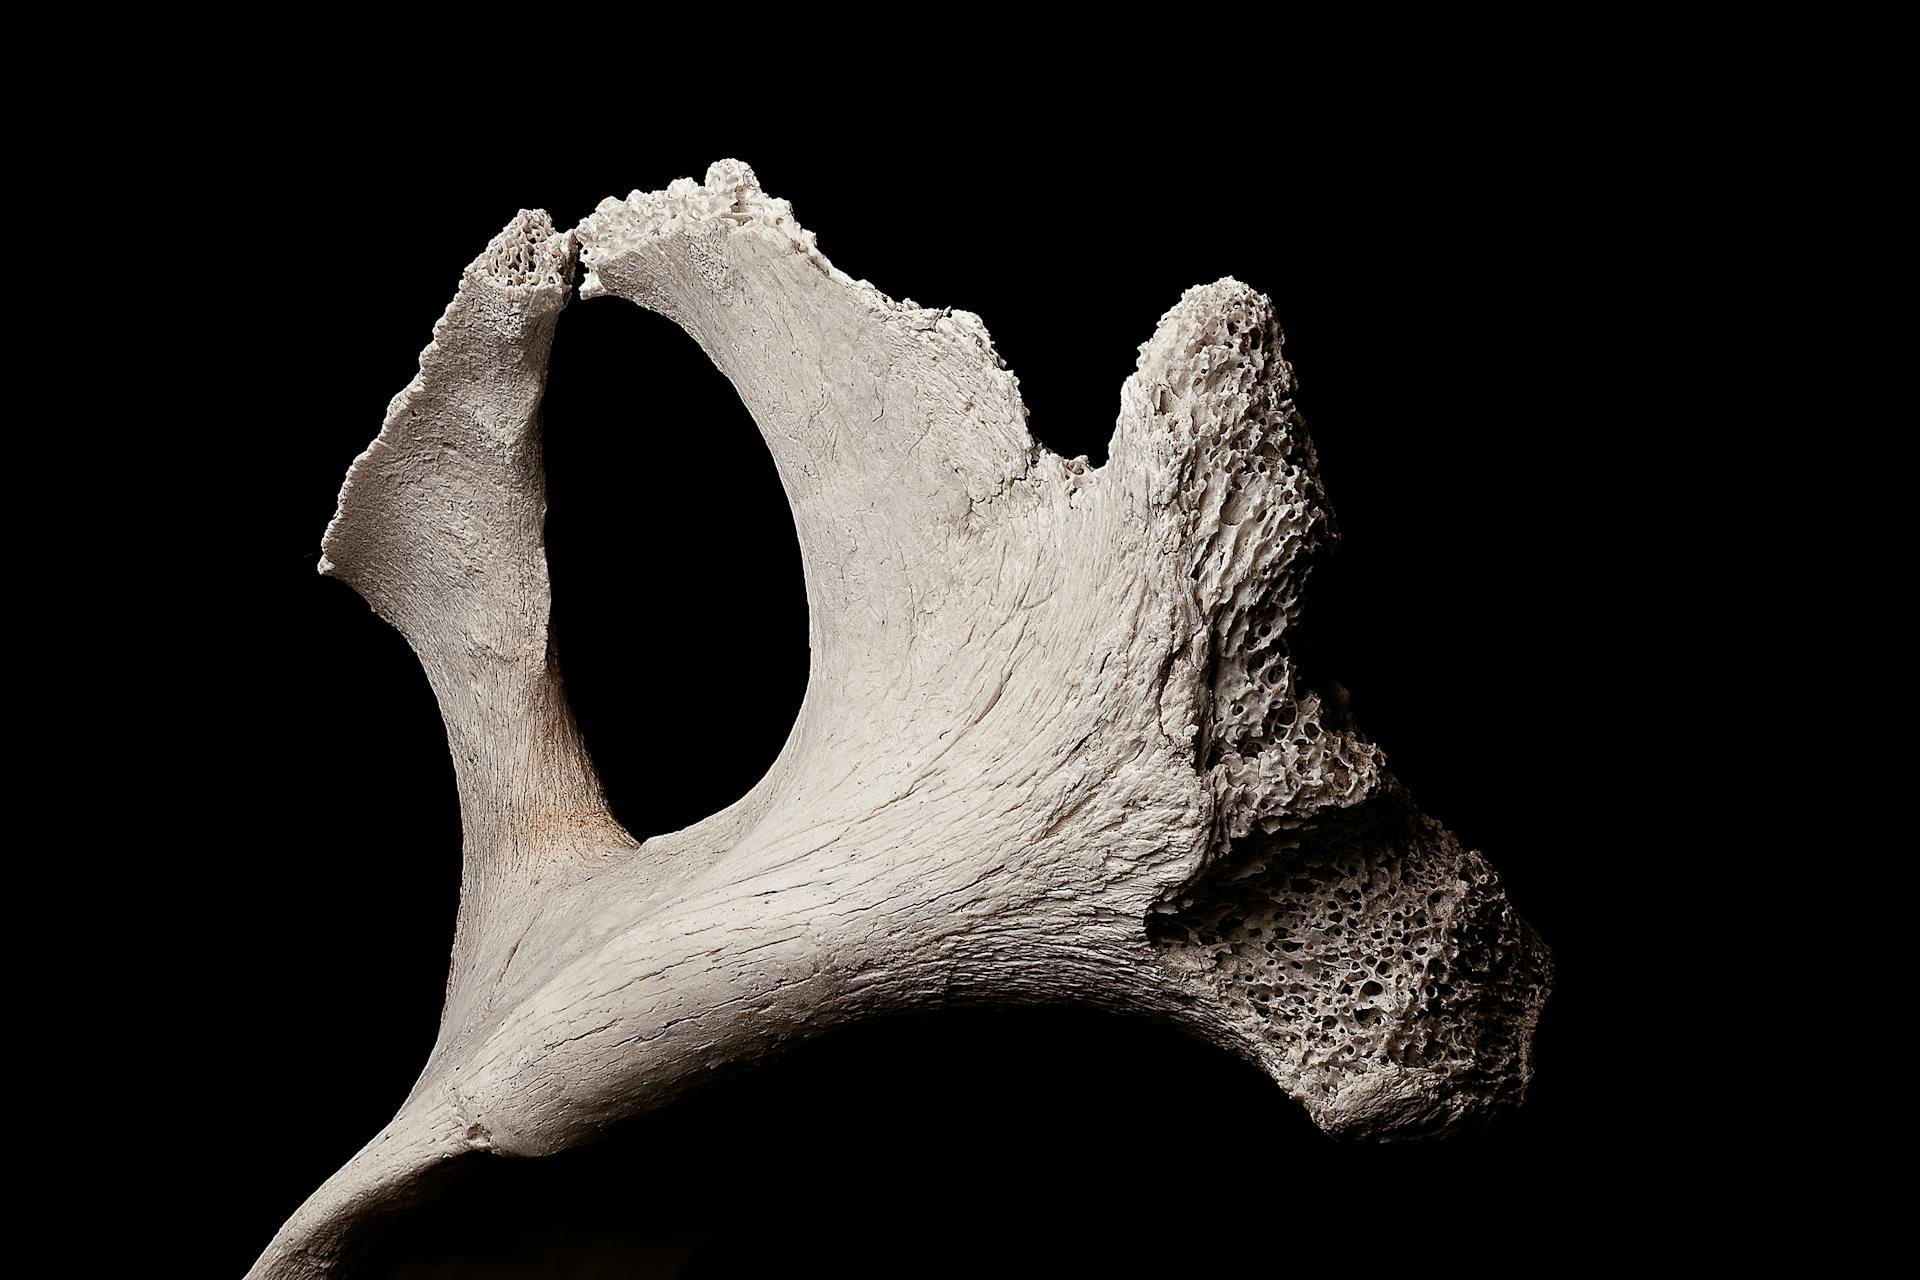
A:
[[321, 209, 624, 898]]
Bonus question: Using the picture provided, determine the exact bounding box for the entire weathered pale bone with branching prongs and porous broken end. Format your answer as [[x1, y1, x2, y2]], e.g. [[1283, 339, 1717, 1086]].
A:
[[252, 161, 1549, 1278]]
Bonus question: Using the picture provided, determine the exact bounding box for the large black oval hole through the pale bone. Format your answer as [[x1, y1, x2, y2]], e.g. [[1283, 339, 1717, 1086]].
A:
[[541, 299, 808, 837]]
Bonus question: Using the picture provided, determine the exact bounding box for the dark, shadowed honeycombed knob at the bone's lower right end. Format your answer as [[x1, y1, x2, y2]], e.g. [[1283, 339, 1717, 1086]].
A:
[[1150, 785, 1551, 1138]]
